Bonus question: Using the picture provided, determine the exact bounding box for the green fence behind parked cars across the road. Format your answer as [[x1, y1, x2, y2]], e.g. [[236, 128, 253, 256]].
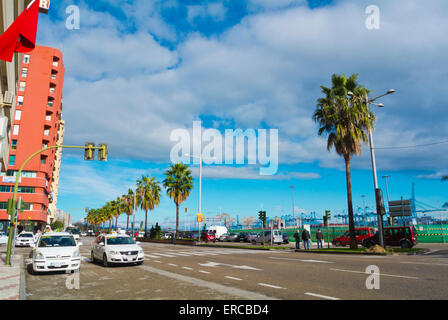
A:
[[229, 224, 448, 243]]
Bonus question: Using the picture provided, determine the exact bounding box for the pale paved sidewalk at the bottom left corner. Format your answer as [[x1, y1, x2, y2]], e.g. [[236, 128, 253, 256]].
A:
[[0, 252, 24, 300]]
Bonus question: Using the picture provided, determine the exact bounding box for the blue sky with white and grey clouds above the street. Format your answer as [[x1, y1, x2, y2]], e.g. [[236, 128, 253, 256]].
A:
[[32, 0, 448, 225]]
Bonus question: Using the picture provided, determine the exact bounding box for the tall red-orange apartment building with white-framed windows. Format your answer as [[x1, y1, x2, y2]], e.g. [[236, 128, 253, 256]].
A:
[[0, 46, 65, 231]]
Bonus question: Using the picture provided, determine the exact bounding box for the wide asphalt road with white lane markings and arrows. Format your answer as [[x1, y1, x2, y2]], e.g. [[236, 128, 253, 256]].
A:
[[12, 238, 448, 300]]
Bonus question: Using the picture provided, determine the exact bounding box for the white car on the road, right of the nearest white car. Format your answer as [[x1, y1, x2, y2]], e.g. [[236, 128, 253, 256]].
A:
[[91, 234, 145, 267]]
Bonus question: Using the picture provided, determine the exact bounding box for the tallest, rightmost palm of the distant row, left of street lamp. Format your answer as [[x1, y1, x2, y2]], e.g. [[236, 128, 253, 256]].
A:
[[163, 163, 193, 236]]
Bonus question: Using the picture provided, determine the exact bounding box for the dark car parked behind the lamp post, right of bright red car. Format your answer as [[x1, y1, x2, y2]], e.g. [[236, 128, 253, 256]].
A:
[[362, 226, 418, 248]]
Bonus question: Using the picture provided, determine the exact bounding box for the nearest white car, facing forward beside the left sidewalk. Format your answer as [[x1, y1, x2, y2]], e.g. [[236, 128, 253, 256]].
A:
[[33, 232, 82, 272]]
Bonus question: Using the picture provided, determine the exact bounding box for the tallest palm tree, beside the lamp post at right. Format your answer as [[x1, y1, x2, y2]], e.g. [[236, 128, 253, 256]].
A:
[[313, 74, 375, 249]]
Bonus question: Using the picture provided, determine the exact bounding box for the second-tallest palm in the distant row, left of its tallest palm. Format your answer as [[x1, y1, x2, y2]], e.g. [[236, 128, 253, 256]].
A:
[[137, 176, 161, 237]]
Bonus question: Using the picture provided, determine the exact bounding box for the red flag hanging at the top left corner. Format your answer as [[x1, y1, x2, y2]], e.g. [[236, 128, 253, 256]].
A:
[[0, 0, 39, 62]]
